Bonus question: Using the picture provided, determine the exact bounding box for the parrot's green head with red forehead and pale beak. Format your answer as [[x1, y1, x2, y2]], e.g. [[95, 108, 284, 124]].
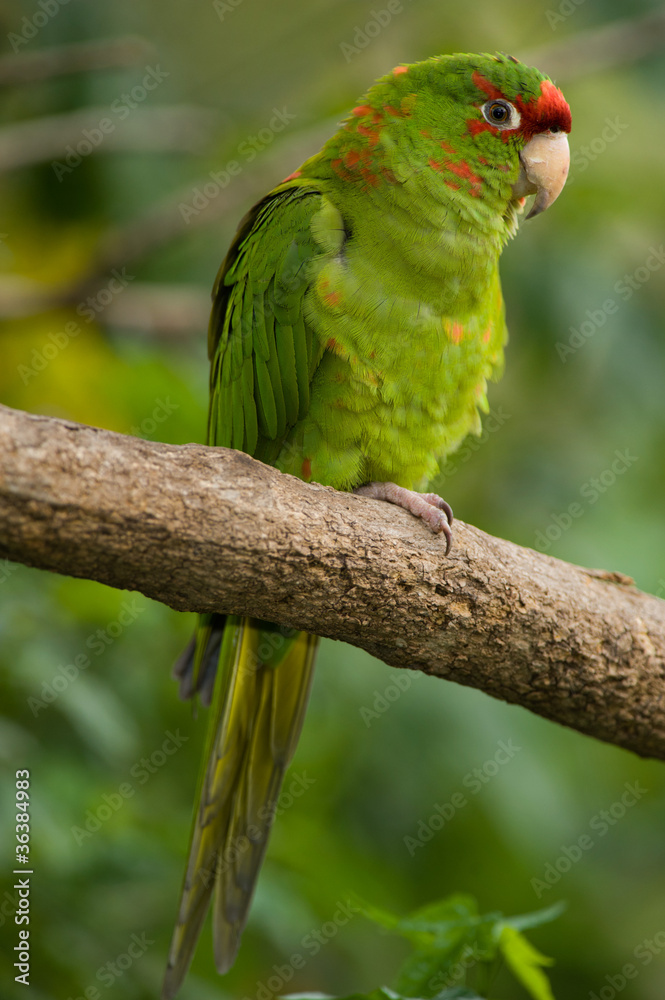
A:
[[348, 54, 571, 229]]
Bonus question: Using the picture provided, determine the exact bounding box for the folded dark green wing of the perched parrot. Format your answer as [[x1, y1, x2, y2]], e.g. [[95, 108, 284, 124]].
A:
[[208, 186, 334, 457]]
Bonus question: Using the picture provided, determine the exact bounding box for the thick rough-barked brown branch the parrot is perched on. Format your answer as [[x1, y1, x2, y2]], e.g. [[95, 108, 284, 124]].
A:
[[0, 407, 665, 758]]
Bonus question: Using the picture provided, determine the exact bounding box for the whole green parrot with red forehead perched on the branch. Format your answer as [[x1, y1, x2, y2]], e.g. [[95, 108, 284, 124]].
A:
[[162, 55, 570, 1000]]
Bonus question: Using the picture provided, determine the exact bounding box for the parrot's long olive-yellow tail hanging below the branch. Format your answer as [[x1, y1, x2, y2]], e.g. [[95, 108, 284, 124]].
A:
[[162, 615, 319, 1000]]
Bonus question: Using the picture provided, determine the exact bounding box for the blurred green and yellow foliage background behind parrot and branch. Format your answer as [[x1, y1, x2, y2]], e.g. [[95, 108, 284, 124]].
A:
[[0, 0, 665, 1000]]
